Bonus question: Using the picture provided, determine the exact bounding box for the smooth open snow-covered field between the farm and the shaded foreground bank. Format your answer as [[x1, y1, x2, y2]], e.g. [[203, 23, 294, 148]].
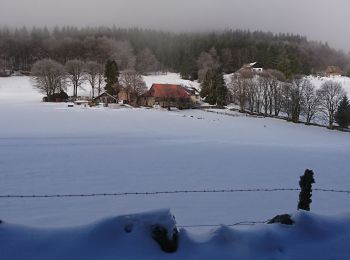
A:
[[0, 77, 350, 259]]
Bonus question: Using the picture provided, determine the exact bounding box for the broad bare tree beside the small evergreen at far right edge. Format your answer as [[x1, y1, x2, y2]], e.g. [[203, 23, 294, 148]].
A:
[[317, 80, 346, 128]]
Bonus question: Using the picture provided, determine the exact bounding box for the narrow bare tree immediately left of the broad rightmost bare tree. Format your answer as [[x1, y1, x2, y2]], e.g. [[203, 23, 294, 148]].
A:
[[303, 81, 320, 124]]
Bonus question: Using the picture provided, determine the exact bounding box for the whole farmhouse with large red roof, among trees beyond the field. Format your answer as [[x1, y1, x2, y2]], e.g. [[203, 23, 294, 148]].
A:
[[140, 84, 193, 109]]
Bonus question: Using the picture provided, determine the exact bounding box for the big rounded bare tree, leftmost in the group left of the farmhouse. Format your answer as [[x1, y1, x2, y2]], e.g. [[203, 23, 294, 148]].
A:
[[31, 59, 65, 98]]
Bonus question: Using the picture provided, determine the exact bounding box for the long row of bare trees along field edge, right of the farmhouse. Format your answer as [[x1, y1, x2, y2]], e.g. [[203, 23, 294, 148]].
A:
[[226, 70, 350, 128]]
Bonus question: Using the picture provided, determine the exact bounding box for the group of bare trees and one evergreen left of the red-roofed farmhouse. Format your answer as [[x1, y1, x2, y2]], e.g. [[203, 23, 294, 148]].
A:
[[31, 59, 147, 101]]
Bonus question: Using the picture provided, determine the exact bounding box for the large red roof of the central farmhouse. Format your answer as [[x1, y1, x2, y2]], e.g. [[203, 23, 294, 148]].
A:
[[146, 84, 191, 98]]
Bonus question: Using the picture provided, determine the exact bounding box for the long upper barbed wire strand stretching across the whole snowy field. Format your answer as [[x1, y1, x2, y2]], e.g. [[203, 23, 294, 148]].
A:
[[0, 188, 350, 199]]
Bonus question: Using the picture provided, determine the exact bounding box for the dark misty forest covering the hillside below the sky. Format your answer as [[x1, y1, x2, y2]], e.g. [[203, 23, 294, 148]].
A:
[[0, 27, 350, 79]]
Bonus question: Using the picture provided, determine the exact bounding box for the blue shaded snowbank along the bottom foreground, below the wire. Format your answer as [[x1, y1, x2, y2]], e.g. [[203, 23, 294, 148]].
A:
[[0, 210, 350, 260]]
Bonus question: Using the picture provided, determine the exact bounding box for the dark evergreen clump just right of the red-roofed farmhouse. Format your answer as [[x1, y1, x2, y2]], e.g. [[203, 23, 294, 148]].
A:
[[200, 69, 228, 106]]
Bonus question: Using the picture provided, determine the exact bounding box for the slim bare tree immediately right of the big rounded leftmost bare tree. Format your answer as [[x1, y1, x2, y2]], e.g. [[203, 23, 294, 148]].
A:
[[65, 60, 85, 97]]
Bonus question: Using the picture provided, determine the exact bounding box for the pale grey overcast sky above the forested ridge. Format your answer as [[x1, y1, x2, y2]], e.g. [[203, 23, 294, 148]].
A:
[[0, 0, 350, 51]]
